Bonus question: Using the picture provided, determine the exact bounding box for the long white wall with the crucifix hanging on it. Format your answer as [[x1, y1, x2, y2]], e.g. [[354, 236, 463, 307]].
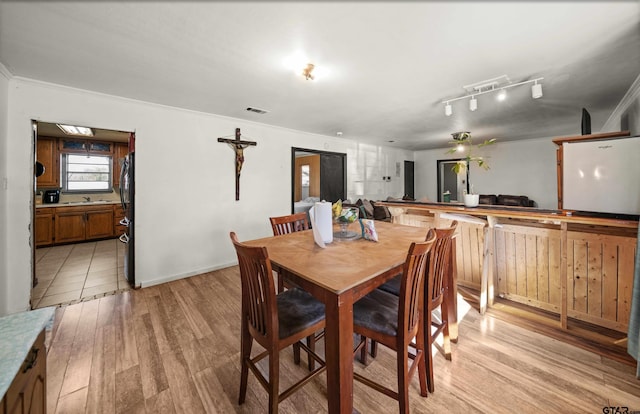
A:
[[3, 78, 413, 312]]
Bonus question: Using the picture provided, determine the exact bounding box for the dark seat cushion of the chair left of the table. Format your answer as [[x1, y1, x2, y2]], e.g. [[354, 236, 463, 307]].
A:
[[276, 288, 324, 339]]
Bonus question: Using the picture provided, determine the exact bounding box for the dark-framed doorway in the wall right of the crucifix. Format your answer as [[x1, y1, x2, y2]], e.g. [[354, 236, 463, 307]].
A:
[[291, 147, 347, 213]]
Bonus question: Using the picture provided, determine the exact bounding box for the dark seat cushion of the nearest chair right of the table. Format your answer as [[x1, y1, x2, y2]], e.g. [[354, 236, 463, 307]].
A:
[[353, 289, 398, 336]]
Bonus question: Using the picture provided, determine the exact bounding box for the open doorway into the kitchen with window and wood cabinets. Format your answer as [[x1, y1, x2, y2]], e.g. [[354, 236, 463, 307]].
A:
[[30, 121, 133, 309]]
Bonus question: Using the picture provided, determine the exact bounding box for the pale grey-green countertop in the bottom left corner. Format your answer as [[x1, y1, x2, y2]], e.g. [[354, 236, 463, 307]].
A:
[[0, 307, 55, 396]]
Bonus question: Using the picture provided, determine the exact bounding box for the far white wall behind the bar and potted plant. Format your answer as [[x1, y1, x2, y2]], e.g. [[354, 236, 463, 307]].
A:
[[414, 138, 558, 209]]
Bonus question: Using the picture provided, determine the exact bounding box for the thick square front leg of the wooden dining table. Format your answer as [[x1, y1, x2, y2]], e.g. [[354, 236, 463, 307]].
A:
[[324, 294, 353, 414]]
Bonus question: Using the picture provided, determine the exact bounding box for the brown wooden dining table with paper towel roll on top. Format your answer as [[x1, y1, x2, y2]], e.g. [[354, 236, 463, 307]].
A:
[[246, 221, 456, 414]]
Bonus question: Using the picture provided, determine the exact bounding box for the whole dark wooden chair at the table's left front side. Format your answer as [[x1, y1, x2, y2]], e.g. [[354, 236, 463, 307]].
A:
[[229, 232, 326, 413]]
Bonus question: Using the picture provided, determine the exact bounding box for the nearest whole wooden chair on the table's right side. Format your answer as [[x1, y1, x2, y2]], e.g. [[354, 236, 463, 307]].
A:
[[353, 230, 436, 414]]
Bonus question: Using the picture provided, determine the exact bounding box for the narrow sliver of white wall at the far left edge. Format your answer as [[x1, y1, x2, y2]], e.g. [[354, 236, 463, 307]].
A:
[[0, 63, 10, 316]]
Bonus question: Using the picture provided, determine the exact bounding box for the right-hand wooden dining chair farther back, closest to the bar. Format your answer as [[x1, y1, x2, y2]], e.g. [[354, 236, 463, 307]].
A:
[[372, 220, 458, 392]]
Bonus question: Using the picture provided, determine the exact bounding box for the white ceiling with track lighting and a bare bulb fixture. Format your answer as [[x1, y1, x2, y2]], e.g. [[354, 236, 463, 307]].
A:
[[0, 0, 640, 150]]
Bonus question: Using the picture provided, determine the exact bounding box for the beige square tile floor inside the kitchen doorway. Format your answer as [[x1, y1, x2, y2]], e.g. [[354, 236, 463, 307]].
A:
[[31, 239, 131, 309]]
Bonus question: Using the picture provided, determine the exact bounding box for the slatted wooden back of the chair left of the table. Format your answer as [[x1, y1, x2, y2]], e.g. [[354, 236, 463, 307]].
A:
[[230, 232, 279, 347]]
